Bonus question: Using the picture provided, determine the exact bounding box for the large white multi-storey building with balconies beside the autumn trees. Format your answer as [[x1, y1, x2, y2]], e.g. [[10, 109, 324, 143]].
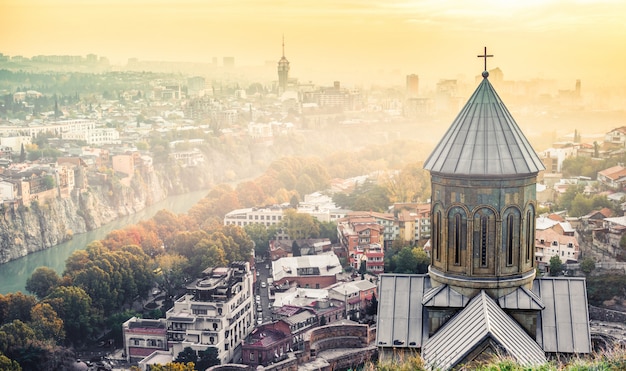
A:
[[166, 262, 254, 364]]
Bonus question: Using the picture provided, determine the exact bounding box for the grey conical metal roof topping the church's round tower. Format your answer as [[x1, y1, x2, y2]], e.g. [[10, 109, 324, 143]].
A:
[[424, 73, 545, 176]]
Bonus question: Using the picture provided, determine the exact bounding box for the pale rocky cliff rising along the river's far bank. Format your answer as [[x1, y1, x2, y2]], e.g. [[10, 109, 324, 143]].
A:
[[0, 140, 259, 264]]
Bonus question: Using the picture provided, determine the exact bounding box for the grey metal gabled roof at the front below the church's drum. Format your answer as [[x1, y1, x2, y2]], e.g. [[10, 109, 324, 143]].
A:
[[422, 291, 547, 370]]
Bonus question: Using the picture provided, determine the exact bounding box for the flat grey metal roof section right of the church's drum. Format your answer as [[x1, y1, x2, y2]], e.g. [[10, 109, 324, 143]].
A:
[[533, 277, 591, 353]]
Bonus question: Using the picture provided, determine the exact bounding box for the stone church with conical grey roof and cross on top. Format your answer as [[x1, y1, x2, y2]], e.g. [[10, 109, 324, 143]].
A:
[[376, 48, 592, 370]]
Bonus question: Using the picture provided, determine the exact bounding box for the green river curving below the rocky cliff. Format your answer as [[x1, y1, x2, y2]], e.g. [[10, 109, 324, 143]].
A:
[[0, 190, 209, 294]]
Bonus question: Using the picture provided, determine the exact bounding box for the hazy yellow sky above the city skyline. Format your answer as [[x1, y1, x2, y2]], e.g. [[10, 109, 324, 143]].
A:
[[0, 0, 626, 87]]
